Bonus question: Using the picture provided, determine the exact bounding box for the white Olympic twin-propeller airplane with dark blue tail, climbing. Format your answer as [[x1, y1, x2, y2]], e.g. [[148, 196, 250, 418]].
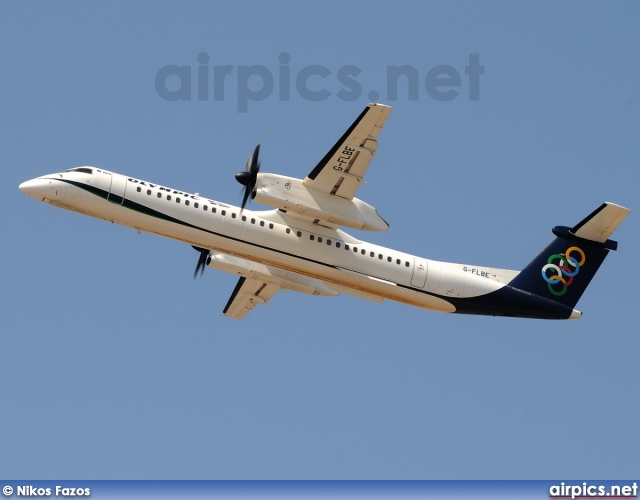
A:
[[19, 103, 630, 319]]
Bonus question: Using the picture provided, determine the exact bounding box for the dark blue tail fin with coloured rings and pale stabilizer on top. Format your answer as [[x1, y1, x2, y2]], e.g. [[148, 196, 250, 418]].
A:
[[509, 202, 631, 308]]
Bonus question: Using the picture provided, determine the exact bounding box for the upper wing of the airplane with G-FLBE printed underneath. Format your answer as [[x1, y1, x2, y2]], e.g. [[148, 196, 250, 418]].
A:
[[304, 103, 392, 200]]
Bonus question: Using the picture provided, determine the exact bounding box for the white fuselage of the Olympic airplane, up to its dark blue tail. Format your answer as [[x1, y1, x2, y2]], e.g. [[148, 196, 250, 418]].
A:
[[20, 167, 518, 312]]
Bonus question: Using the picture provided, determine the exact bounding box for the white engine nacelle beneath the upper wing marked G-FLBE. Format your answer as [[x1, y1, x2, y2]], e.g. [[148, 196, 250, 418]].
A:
[[252, 174, 389, 231]]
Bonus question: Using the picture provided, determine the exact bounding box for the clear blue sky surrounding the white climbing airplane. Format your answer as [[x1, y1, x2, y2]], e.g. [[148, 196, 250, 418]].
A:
[[0, 2, 640, 479]]
